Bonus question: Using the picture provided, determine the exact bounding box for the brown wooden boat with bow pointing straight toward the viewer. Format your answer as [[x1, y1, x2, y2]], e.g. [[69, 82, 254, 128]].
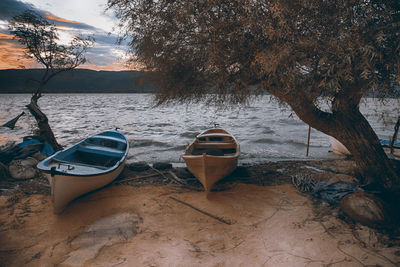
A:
[[182, 128, 240, 197]]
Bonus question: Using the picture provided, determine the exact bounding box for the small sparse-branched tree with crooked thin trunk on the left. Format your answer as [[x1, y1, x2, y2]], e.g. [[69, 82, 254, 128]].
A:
[[9, 10, 94, 150]]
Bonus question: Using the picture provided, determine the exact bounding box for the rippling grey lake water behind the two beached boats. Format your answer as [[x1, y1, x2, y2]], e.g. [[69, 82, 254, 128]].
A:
[[0, 94, 399, 166]]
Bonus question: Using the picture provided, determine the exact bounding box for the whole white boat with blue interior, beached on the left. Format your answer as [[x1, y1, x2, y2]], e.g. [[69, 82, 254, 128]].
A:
[[37, 131, 129, 214]]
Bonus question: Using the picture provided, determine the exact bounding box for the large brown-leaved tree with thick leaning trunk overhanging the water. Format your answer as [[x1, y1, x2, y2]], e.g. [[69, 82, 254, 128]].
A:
[[108, 0, 400, 193]]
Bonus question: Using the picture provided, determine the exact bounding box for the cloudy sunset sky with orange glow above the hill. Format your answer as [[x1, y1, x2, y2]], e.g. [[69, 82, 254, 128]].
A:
[[0, 0, 127, 70]]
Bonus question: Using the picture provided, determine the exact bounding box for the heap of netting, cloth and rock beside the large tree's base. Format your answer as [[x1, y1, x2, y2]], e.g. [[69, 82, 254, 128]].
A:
[[292, 163, 399, 231]]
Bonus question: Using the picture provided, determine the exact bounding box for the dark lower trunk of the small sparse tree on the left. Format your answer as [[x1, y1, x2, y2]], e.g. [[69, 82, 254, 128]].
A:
[[26, 93, 62, 151]]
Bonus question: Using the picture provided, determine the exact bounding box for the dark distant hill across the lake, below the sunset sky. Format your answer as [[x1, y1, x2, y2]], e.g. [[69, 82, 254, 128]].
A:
[[0, 69, 155, 93]]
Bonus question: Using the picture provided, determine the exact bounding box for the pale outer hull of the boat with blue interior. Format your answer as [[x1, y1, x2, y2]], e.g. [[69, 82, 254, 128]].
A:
[[45, 164, 125, 214]]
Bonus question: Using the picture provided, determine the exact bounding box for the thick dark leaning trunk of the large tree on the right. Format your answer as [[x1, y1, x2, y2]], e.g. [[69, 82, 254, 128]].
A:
[[280, 91, 400, 192]]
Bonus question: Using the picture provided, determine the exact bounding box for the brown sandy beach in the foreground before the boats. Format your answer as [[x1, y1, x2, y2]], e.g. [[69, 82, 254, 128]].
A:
[[0, 160, 400, 266]]
